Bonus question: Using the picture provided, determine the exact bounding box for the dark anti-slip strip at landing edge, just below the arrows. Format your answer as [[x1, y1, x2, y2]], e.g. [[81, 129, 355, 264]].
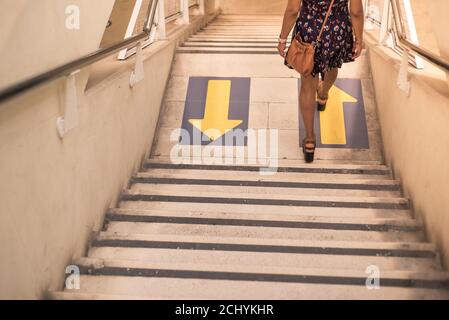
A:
[[144, 162, 391, 175]]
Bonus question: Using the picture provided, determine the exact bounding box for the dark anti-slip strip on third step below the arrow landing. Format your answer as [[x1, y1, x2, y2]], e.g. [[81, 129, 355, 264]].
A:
[[121, 194, 410, 209]]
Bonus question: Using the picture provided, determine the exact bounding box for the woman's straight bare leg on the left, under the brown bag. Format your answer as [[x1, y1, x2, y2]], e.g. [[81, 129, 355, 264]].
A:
[[299, 76, 318, 148]]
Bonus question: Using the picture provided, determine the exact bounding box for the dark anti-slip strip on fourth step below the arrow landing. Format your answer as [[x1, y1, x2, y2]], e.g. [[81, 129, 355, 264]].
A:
[[106, 213, 422, 232]]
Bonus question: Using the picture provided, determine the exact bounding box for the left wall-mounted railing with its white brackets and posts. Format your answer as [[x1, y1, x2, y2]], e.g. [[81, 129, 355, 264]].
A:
[[0, 0, 204, 138]]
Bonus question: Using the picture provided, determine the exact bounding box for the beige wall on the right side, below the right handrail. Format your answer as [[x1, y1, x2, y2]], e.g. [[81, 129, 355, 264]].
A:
[[369, 41, 449, 268]]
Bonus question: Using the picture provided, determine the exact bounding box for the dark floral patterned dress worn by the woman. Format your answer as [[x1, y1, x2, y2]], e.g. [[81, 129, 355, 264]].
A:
[[293, 0, 354, 77]]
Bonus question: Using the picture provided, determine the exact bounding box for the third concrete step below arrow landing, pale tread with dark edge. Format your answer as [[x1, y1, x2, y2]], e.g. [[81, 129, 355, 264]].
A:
[[121, 188, 410, 209]]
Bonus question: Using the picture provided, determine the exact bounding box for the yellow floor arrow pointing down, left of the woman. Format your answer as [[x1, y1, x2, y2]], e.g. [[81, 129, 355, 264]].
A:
[[189, 80, 243, 141]]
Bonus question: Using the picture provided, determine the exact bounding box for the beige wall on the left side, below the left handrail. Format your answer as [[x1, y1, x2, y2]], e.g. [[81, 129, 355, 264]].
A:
[[0, 0, 217, 299]]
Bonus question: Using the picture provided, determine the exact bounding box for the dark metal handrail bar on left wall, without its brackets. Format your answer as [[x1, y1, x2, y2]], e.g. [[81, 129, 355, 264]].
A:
[[0, 0, 159, 103]]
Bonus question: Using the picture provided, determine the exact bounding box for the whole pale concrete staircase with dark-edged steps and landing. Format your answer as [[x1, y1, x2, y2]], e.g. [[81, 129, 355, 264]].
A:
[[52, 16, 449, 300]]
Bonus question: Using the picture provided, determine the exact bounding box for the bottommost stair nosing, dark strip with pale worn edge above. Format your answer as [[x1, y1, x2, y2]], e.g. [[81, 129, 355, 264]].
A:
[[74, 259, 449, 290]]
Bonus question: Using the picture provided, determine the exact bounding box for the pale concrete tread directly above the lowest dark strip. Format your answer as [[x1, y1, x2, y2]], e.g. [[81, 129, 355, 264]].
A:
[[89, 247, 440, 272]]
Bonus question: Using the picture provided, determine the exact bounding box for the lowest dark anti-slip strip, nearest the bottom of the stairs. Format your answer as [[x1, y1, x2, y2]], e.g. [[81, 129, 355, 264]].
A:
[[80, 266, 449, 289]]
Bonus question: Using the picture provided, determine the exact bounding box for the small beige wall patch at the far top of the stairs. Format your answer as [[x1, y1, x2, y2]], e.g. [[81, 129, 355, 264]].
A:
[[220, 0, 288, 15]]
